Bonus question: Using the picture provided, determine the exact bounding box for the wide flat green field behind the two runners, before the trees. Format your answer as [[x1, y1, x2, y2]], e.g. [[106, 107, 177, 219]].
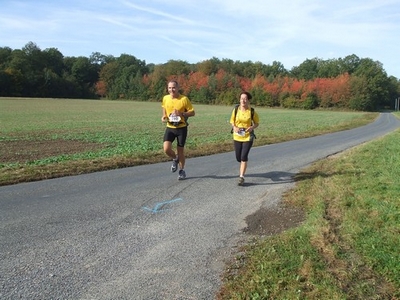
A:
[[0, 98, 377, 185]]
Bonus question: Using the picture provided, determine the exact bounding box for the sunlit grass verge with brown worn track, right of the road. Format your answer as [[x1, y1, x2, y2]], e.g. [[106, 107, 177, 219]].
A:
[[218, 123, 400, 300]]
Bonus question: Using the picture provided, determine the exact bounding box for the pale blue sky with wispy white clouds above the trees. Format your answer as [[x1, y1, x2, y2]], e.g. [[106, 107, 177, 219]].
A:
[[0, 0, 400, 79]]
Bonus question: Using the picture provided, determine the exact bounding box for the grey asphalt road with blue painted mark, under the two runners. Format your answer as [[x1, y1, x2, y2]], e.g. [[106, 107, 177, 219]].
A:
[[0, 113, 400, 300]]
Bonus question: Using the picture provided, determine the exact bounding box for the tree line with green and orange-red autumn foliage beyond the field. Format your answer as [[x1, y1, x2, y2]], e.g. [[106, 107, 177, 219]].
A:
[[0, 42, 400, 111]]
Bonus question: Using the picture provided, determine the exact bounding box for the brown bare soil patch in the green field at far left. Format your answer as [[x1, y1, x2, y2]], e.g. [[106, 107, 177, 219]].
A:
[[0, 140, 104, 163]]
